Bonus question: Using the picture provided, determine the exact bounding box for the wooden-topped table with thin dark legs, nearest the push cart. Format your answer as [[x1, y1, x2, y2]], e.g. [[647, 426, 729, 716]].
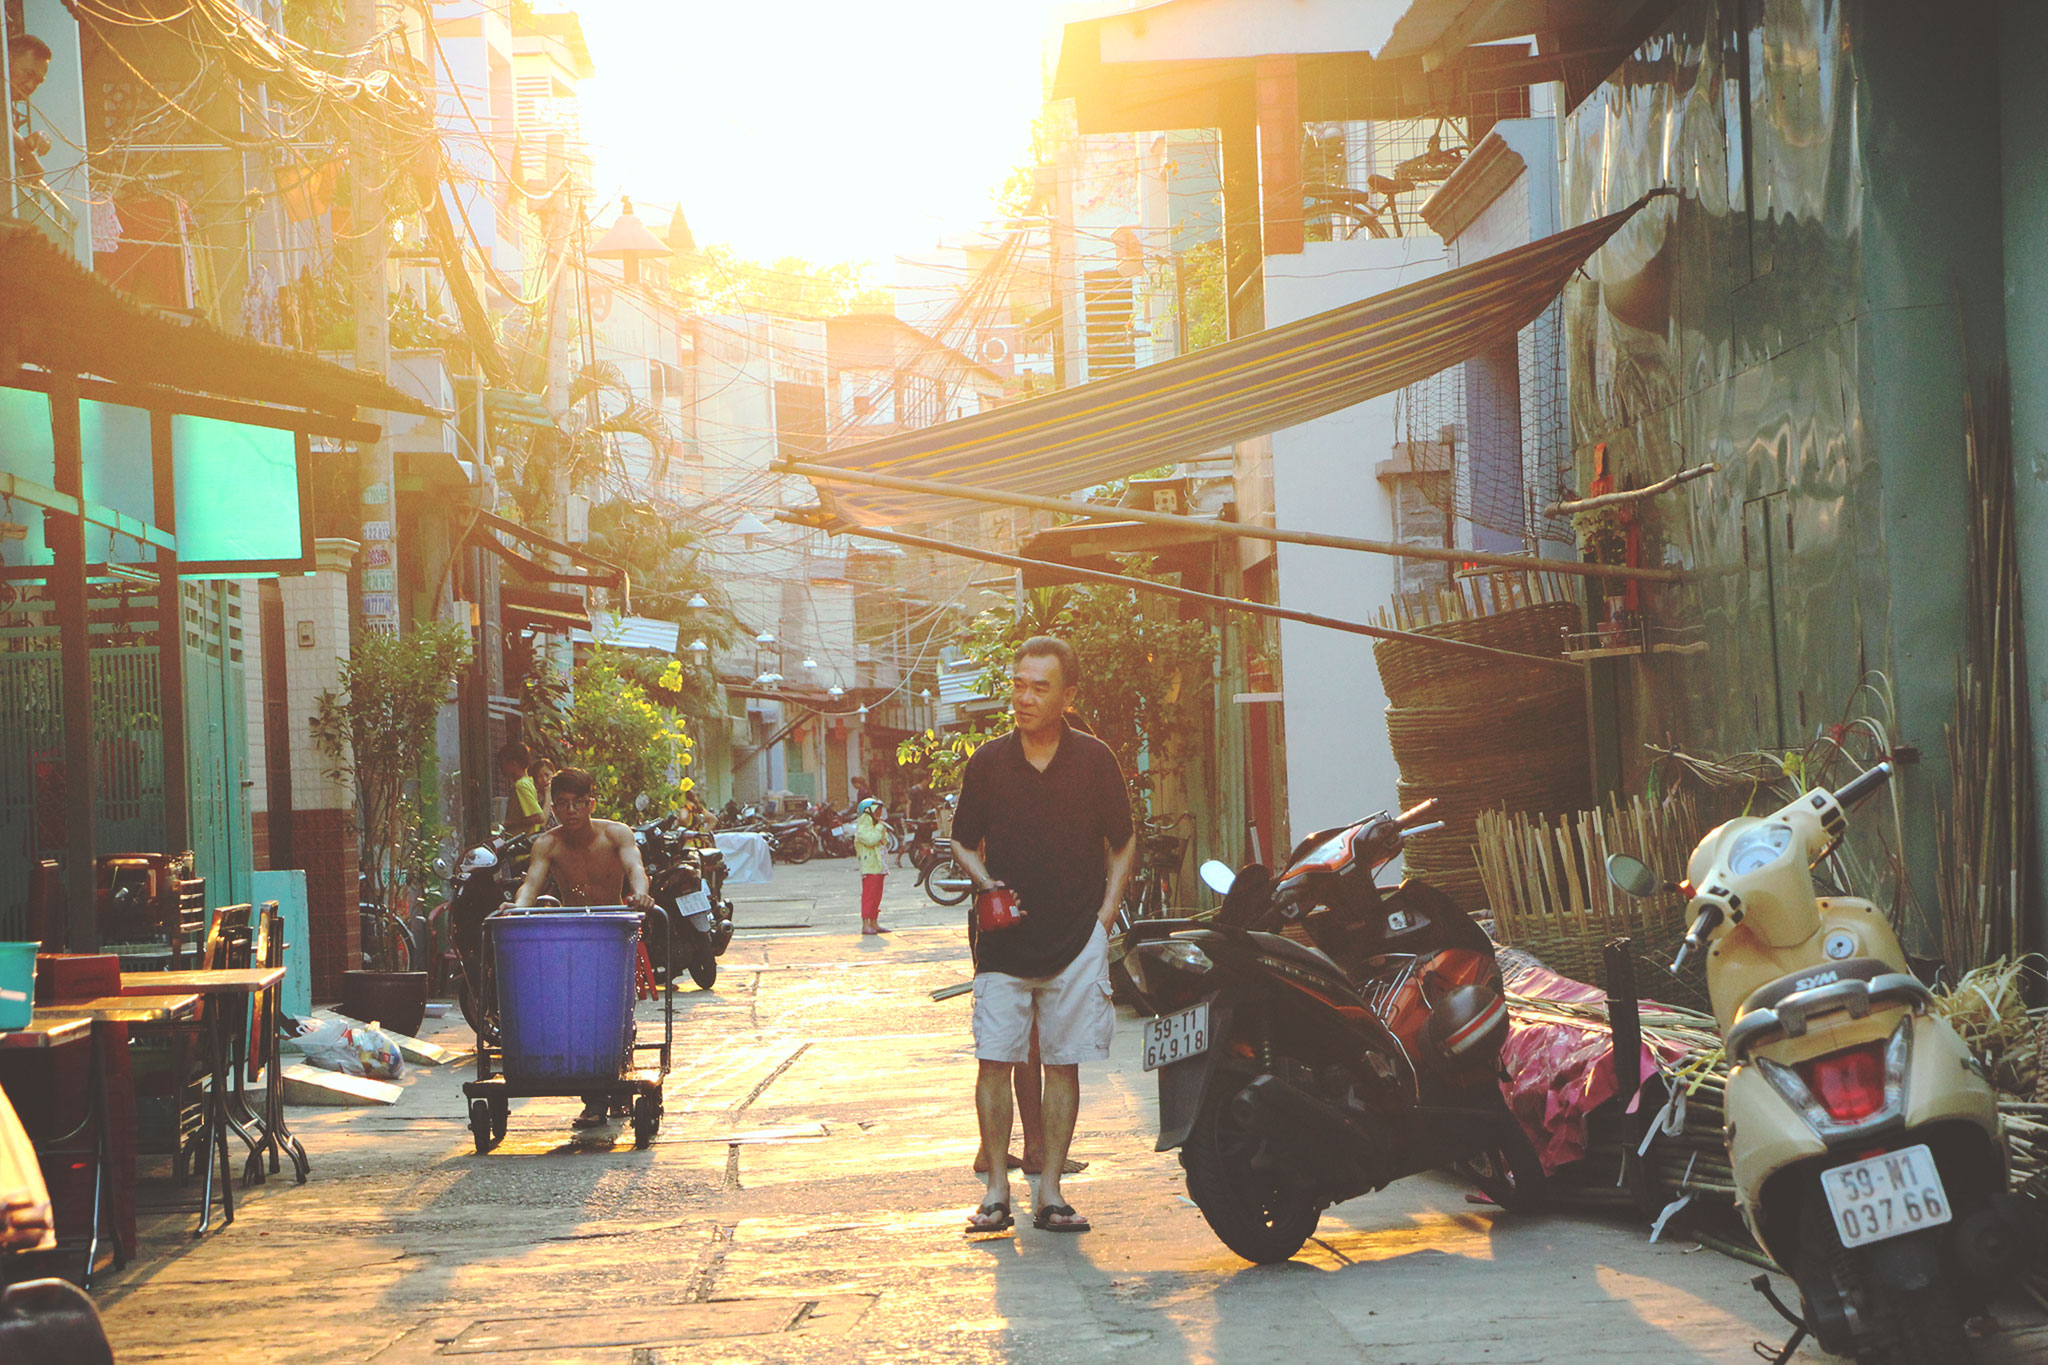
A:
[[121, 966, 296, 1234]]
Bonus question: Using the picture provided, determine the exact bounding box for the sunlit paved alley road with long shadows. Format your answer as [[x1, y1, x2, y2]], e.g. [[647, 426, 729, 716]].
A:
[[100, 862, 2048, 1365]]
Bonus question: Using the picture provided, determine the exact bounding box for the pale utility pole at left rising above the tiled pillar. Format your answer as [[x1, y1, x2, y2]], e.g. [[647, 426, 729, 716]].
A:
[[344, 0, 399, 634]]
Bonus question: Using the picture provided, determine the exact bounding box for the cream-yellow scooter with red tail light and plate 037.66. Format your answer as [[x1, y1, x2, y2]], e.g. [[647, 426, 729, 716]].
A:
[[1608, 763, 2034, 1365]]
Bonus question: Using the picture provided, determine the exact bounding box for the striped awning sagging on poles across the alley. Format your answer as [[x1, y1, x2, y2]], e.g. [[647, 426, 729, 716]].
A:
[[811, 190, 1665, 526]]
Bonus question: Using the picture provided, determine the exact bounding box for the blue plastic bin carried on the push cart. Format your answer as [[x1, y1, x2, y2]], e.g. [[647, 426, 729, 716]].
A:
[[483, 909, 641, 1085]]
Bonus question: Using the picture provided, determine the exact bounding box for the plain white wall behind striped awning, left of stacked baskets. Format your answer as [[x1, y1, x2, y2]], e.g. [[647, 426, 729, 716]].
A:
[[1266, 237, 1444, 839]]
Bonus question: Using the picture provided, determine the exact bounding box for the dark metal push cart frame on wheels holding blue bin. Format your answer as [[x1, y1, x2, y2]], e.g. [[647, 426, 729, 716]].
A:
[[463, 905, 680, 1152]]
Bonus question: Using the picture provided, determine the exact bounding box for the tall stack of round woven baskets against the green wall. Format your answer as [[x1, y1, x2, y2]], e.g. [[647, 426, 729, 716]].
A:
[[1372, 575, 1591, 911]]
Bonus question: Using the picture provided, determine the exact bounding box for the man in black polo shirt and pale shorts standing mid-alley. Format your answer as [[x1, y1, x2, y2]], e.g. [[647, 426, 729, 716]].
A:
[[952, 634, 1137, 1232]]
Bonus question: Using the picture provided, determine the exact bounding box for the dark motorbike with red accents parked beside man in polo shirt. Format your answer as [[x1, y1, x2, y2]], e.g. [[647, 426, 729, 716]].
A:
[[1126, 802, 1542, 1263]]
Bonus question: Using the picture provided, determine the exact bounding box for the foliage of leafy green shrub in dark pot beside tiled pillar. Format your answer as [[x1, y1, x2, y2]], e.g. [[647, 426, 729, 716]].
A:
[[313, 622, 469, 905]]
